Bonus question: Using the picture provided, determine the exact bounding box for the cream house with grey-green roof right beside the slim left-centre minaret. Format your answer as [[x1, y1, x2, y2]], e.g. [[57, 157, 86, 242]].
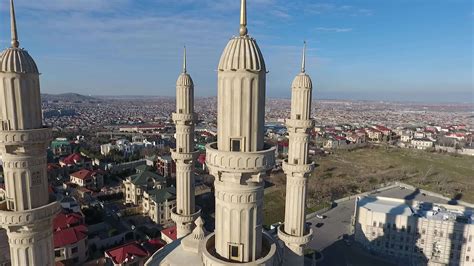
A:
[[142, 187, 176, 224]]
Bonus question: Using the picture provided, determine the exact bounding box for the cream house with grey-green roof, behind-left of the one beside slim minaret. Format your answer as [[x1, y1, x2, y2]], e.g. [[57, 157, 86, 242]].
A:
[[123, 166, 166, 205]]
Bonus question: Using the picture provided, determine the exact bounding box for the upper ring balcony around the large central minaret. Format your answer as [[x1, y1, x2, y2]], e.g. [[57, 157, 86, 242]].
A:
[[206, 142, 276, 173]]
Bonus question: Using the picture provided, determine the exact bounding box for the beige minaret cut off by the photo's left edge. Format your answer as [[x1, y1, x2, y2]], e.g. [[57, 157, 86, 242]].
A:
[[0, 0, 60, 266]]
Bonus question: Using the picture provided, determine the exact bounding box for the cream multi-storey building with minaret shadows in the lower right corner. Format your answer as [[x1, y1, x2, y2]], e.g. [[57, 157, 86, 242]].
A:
[[354, 197, 474, 266]]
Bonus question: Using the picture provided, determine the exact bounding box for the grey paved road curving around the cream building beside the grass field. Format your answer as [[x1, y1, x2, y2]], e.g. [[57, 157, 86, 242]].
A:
[[308, 188, 454, 266]]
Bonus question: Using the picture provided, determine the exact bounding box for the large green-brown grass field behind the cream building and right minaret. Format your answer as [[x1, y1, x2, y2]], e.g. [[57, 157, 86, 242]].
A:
[[264, 148, 474, 224]]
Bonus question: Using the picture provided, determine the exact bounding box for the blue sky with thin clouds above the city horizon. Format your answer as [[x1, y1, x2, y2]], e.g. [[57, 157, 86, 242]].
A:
[[0, 0, 474, 102]]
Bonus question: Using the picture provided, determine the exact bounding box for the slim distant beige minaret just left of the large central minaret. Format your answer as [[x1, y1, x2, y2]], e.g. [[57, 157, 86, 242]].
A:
[[171, 47, 200, 238]]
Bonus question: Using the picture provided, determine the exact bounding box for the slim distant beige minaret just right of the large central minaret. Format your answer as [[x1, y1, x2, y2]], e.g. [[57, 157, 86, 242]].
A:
[[278, 43, 313, 265]]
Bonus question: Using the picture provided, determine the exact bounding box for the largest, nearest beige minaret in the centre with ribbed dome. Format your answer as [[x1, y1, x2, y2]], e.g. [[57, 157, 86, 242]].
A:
[[203, 0, 276, 265]]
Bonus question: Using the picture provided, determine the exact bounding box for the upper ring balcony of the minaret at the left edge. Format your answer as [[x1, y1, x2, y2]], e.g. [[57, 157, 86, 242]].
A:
[[0, 128, 53, 146]]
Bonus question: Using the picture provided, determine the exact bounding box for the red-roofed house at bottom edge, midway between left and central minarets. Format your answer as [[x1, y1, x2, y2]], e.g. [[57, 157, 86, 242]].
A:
[[105, 242, 150, 266]]
